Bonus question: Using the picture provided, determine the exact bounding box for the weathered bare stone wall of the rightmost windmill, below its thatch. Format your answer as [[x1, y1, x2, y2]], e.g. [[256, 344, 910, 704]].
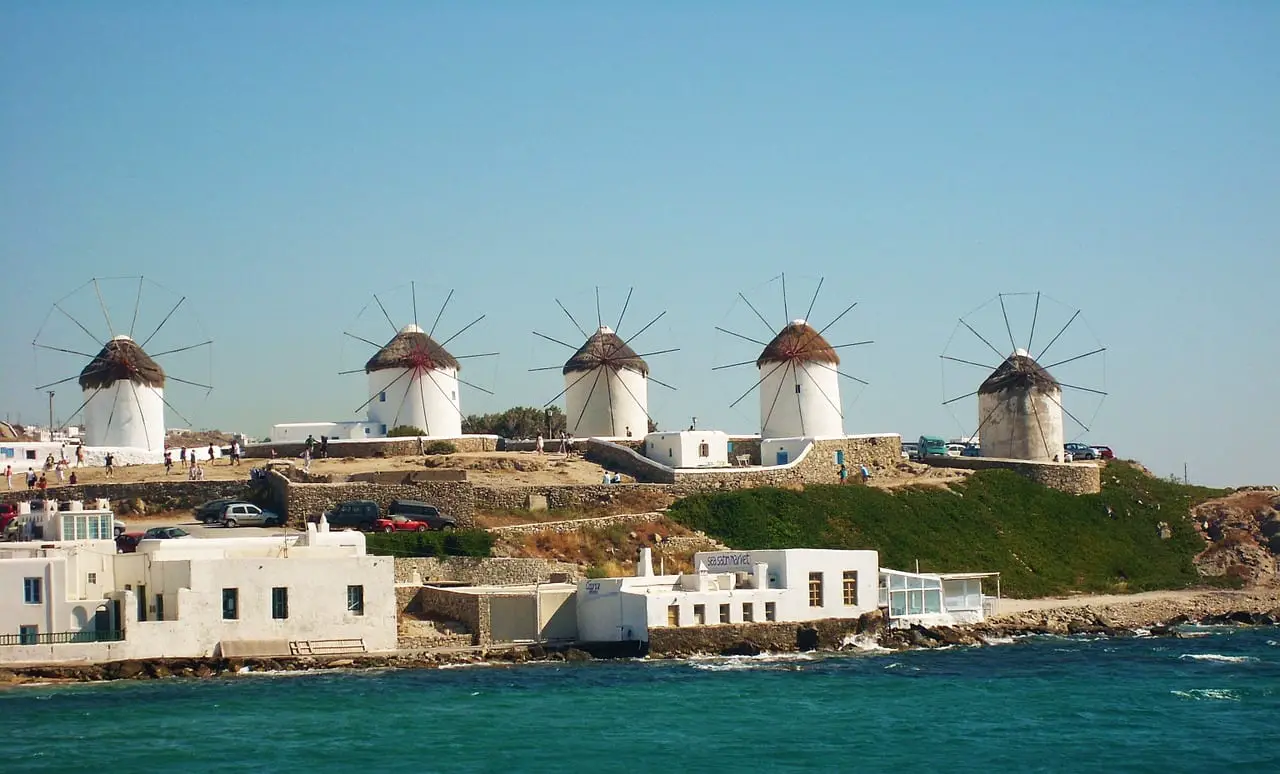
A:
[[978, 389, 1064, 462]]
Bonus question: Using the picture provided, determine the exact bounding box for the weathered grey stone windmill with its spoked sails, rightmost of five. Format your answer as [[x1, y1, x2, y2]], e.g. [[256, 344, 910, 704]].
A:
[[942, 293, 1106, 462]]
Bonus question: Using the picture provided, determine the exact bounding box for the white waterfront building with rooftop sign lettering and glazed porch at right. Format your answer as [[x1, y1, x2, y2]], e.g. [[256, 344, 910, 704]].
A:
[[577, 549, 984, 642]]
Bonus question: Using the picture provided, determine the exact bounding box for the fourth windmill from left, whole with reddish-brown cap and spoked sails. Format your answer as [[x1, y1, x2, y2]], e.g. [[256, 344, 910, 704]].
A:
[[712, 274, 873, 439]]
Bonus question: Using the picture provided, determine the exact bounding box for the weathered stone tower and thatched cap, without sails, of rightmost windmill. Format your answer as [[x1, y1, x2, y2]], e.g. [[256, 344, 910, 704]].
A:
[[978, 349, 1065, 462]]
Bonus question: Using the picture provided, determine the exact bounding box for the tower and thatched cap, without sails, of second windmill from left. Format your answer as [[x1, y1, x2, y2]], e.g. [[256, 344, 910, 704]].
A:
[[365, 325, 462, 438]]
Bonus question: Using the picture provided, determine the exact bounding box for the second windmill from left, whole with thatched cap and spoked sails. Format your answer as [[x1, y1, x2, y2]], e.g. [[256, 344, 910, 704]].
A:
[[339, 283, 498, 438]]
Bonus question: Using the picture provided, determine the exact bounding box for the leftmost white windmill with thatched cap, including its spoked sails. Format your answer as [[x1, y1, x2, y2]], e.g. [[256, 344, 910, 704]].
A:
[[32, 276, 212, 454]]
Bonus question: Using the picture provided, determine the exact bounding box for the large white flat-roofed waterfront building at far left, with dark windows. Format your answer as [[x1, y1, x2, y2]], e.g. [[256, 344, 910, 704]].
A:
[[0, 506, 397, 663]]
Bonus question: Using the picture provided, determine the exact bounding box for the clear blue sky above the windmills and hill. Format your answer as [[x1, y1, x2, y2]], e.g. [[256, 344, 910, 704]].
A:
[[0, 1, 1280, 484]]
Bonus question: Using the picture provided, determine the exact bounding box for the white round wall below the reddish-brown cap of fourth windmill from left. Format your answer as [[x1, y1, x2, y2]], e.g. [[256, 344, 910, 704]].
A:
[[756, 363, 845, 438]]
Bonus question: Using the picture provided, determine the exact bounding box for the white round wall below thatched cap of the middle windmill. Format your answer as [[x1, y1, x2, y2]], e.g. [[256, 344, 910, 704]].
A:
[[564, 367, 649, 438]]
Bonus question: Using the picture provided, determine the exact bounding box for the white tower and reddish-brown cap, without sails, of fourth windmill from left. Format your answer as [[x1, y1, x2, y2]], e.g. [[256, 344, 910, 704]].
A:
[[755, 320, 845, 438]]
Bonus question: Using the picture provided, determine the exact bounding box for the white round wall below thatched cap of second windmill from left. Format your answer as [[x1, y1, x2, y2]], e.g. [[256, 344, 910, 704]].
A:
[[366, 368, 462, 438]]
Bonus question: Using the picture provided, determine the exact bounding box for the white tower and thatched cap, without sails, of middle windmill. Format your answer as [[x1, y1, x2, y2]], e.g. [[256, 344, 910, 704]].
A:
[[562, 325, 649, 438]]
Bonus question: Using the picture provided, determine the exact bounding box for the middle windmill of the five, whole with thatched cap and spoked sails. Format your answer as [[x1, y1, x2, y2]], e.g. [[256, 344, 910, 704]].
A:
[[530, 288, 678, 438]]
